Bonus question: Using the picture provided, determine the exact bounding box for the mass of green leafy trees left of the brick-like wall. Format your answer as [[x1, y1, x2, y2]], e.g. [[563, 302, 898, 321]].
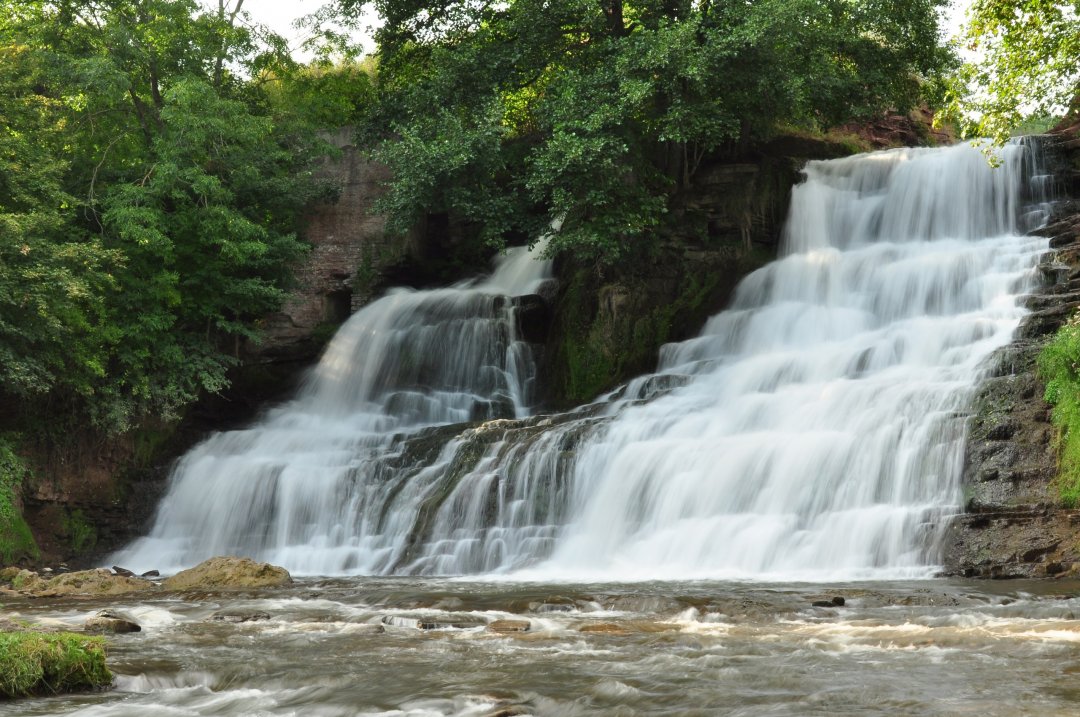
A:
[[0, 0, 349, 433]]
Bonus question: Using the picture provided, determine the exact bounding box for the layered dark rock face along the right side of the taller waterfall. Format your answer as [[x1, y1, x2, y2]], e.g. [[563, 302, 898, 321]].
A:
[[945, 131, 1080, 578]]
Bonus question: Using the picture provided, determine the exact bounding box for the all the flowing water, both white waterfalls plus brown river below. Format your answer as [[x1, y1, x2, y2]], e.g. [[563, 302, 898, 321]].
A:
[[6, 145, 1067, 717]]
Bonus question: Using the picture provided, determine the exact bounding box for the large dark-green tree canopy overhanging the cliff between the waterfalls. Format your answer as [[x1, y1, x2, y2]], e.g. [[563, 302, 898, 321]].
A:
[[338, 0, 947, 262]]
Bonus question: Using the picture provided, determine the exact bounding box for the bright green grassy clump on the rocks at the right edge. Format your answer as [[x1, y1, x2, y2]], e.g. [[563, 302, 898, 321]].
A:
[[1038, 316, 1080, 508]]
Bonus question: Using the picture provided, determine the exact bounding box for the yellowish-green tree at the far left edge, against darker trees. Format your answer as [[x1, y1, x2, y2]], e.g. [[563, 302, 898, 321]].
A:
[[0, 45, 119, 397]]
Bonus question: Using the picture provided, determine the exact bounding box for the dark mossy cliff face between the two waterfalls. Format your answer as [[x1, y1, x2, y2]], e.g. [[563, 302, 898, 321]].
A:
[[543, 136, 855, 407]]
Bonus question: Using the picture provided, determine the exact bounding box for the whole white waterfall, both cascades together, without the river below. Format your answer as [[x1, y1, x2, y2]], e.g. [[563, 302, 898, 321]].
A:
[[116, 145, 1047, 580]]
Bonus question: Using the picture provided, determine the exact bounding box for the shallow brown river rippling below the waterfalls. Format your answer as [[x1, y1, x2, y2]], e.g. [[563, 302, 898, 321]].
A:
[[2, 578, 1080, 717]]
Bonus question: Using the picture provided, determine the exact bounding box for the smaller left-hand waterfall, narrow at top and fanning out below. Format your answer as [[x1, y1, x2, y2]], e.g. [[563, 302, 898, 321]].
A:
[[116, 242, 551, 573]]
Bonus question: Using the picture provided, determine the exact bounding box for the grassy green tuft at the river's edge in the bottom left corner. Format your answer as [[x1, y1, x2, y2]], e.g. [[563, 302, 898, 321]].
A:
[[0, 632, 112, 699]]
